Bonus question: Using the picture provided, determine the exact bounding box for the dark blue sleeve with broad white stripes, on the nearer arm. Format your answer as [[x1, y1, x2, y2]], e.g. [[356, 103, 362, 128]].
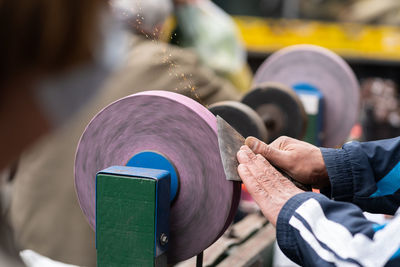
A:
[[277, 192, 400, 266]]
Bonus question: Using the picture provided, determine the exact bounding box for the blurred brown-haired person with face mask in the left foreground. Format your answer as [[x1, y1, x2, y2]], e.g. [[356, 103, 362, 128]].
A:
[[0, 0, 108, 266]]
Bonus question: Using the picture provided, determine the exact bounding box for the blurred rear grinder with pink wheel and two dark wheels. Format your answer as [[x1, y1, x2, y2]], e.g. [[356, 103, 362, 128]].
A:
[[210, 45, 360, 147]]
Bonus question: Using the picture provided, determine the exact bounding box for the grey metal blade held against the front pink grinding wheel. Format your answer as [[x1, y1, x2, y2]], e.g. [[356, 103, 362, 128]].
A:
[[217, 116, 245, 182]]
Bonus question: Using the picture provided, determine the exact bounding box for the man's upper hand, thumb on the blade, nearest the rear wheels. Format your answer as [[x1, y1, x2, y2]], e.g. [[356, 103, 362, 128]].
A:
[[246, 136, 329, 188]]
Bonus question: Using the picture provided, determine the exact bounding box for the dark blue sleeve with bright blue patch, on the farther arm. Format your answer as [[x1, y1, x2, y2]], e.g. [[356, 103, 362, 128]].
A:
[[321, 137, 400, 214]]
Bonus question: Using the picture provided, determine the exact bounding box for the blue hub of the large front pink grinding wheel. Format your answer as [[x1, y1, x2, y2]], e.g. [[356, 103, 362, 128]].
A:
[[126, 151, 179, 202]]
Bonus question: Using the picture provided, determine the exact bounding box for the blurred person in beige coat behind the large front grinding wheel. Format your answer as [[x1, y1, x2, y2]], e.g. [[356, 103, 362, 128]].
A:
[[10, 0, 239, 266]]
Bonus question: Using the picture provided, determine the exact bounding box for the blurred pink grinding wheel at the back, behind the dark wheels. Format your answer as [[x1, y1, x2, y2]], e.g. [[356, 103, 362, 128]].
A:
[[254, 45, 360, 147]]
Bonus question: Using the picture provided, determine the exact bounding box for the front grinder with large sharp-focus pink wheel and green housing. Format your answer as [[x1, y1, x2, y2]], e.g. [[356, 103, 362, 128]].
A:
[[75, 91, 244, 266]]
